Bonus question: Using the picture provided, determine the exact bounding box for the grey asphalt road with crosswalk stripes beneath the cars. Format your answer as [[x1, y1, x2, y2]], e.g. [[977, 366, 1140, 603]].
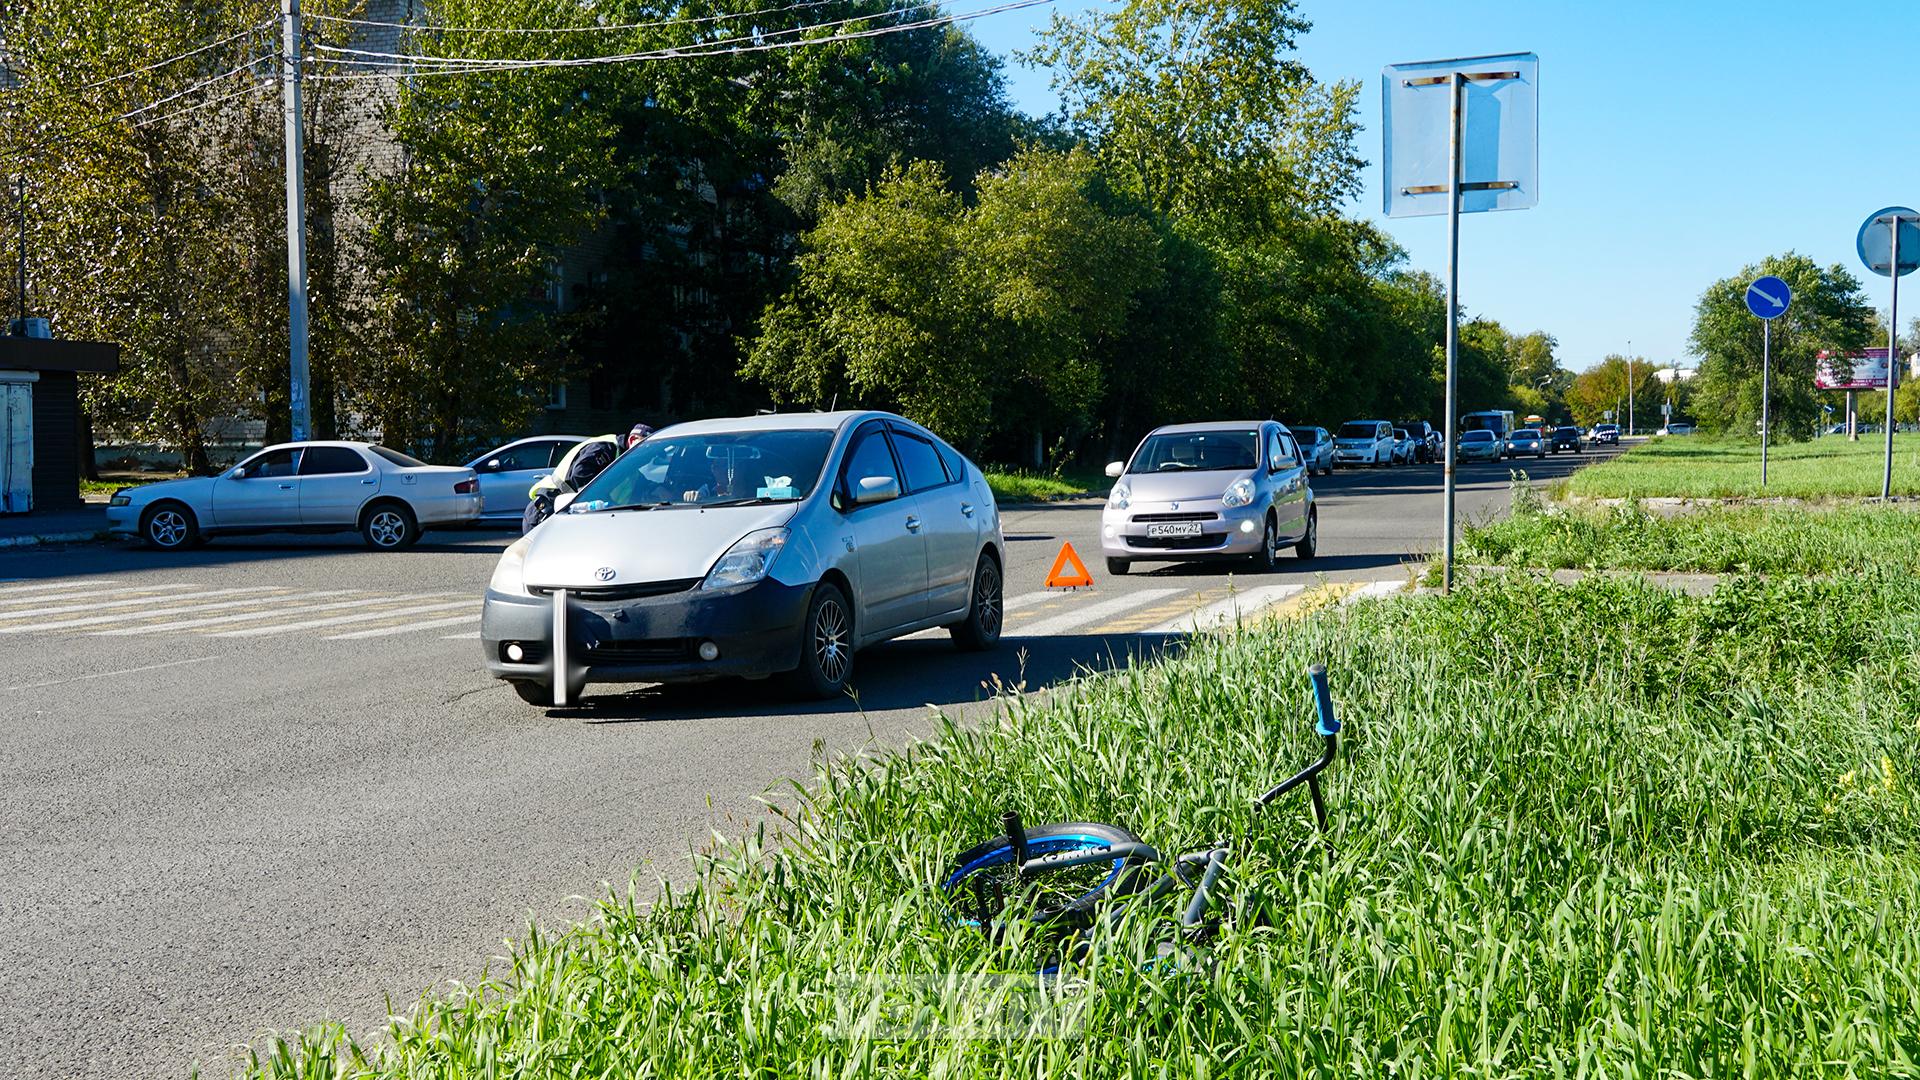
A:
[[0, 443, 1594, 1078]]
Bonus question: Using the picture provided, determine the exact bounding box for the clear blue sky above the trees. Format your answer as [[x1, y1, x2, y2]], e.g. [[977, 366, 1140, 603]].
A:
[[972, 0, 1920, 371]]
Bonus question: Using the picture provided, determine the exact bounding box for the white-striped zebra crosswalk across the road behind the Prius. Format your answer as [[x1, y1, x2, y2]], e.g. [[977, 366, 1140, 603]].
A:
[[0, 578, 1405, 642]]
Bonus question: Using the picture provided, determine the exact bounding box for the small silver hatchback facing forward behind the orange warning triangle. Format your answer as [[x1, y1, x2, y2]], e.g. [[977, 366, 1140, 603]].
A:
[[1100, 421, 1319, 575]]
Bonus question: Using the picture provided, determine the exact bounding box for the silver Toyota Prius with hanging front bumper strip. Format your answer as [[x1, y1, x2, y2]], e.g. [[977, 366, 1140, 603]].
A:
[[480, 411, 1006, 705]]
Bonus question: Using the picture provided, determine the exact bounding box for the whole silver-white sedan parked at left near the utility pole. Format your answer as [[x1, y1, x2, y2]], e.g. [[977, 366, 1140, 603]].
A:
[[108, 442, 480, 552]]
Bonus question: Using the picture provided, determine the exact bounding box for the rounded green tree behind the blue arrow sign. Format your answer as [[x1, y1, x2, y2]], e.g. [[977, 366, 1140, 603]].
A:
[[1690, 252, 1874, 440]]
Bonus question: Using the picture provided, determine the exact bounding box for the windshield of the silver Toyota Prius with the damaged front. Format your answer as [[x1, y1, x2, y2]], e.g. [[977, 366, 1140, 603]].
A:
[[568, 429, 833, 513]]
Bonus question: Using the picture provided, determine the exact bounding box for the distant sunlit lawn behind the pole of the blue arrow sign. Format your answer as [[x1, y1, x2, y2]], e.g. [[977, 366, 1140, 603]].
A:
[[1567, 434, 1920, 500]]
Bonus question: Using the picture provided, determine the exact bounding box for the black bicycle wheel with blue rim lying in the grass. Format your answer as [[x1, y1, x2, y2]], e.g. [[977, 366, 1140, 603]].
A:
[[941, 821, 1152, 928]]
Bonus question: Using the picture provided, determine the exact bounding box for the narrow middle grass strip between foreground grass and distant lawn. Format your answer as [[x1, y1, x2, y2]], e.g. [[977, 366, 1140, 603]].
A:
[[1461, 500, 1920, 575]]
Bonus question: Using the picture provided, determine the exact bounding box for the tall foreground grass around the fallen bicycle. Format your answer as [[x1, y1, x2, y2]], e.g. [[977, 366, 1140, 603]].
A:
[[252, 575, 1920, 1078]]
